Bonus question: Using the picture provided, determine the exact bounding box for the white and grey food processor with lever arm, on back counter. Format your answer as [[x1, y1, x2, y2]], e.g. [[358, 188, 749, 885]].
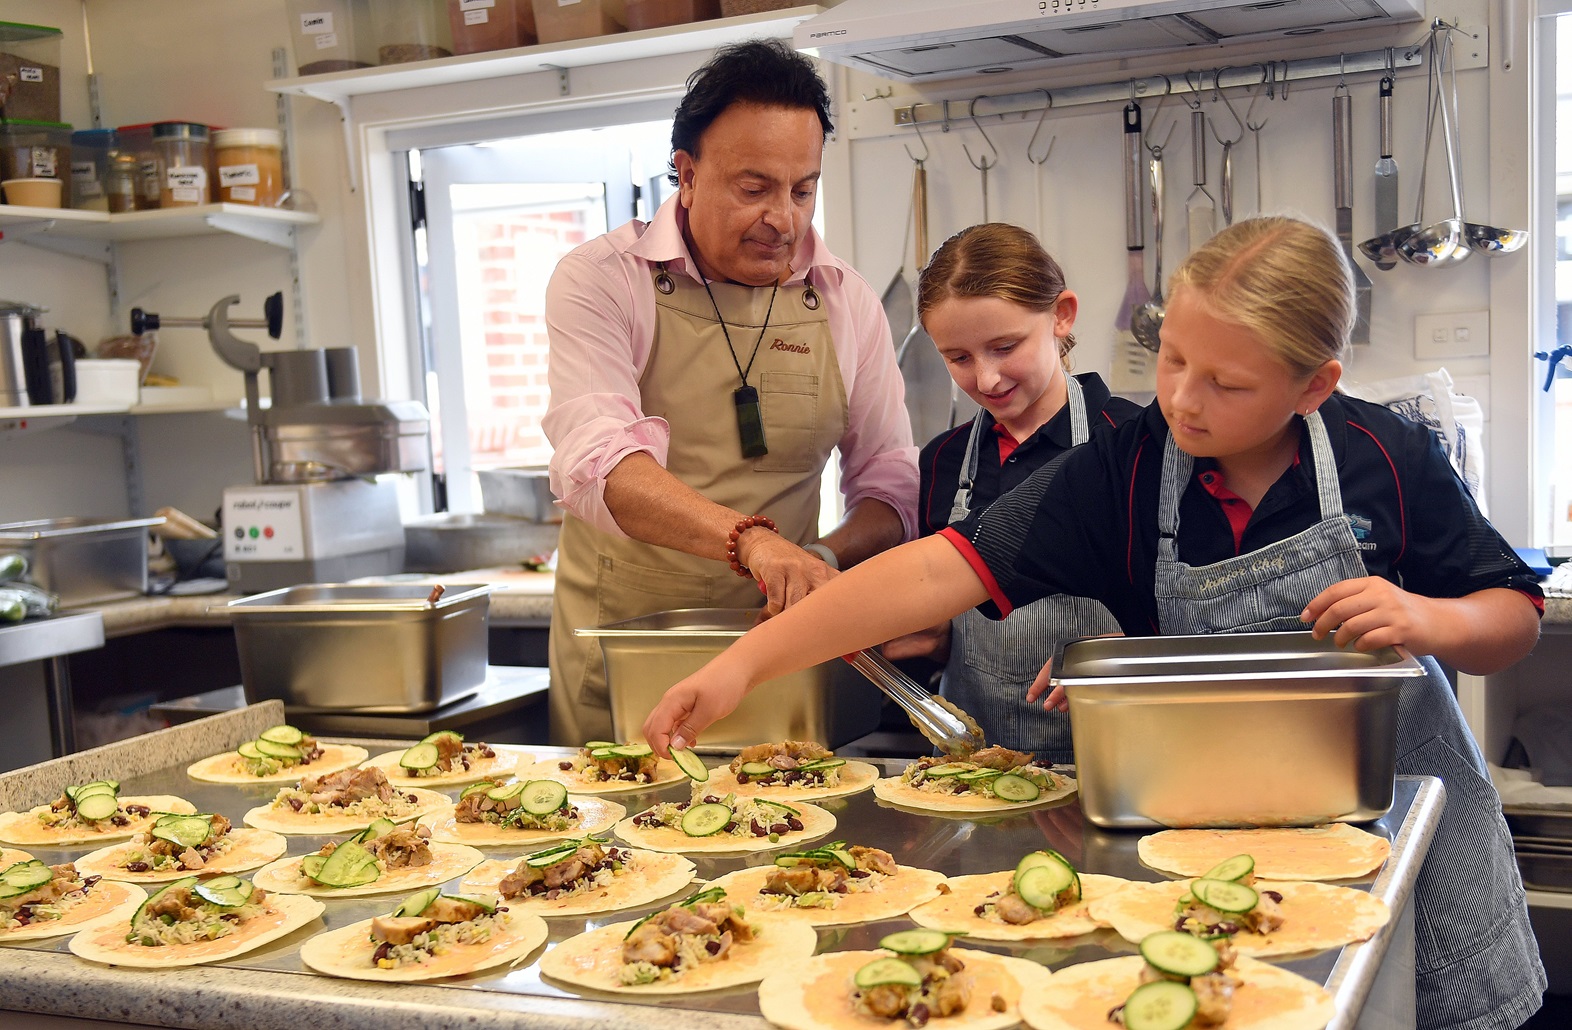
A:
[[130, 294, 429, 593]]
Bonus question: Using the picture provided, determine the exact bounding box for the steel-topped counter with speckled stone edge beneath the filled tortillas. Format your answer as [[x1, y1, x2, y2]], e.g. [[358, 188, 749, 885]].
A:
[[0, 701, 1445, 1030]]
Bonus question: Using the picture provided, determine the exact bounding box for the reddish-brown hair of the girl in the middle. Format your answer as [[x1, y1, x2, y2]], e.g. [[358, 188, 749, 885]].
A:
[[916, 222, 1075, 362]]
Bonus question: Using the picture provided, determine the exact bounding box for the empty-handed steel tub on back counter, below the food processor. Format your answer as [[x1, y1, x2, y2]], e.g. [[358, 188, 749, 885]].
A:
[[228, 583, 490, 712]]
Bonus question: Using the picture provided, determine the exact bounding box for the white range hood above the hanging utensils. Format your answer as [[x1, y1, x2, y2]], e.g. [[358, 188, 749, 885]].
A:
[[795, 0, 1424, 80]]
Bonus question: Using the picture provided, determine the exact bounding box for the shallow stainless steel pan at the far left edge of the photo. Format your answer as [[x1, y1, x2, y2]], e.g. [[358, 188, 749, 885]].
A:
[[0, 516, 163, 609]]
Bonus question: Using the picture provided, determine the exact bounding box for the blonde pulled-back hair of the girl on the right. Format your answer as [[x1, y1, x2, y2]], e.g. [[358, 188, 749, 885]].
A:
[[1168, 215, 1355, 377]]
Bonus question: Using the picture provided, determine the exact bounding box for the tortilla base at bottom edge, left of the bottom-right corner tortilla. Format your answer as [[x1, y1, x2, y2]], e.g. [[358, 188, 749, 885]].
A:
[[759, 948, 1050, 1030]]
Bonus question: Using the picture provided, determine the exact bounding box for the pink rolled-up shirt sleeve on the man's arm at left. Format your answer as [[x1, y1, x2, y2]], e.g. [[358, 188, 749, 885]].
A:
[[541, 250, 671, 536]]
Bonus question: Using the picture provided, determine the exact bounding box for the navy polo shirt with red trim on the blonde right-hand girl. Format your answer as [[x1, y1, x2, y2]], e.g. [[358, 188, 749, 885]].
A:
[[943, 393, 1544, 637]]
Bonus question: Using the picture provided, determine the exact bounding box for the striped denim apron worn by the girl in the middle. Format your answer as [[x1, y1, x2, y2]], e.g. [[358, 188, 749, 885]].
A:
[[938, 376, 1119, 764]]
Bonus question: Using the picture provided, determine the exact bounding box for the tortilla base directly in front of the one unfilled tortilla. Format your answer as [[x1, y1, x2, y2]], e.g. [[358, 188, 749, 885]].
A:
[[1091, 879, 1391, 956]]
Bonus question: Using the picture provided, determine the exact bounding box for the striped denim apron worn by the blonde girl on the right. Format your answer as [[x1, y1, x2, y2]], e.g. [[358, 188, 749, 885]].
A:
[[1155, 412, 1545, 1030]]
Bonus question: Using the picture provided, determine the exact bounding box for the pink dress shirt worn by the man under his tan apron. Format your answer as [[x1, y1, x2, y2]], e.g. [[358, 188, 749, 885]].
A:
[[542, 197, 918, 539]]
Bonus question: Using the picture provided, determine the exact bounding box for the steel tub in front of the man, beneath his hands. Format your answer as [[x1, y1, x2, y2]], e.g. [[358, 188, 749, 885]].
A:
[[574, 609, 883, 753]]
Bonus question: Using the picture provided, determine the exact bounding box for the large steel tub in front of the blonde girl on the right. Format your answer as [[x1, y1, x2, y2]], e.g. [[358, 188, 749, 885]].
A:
[[1053, 632, 1424, 829]]
